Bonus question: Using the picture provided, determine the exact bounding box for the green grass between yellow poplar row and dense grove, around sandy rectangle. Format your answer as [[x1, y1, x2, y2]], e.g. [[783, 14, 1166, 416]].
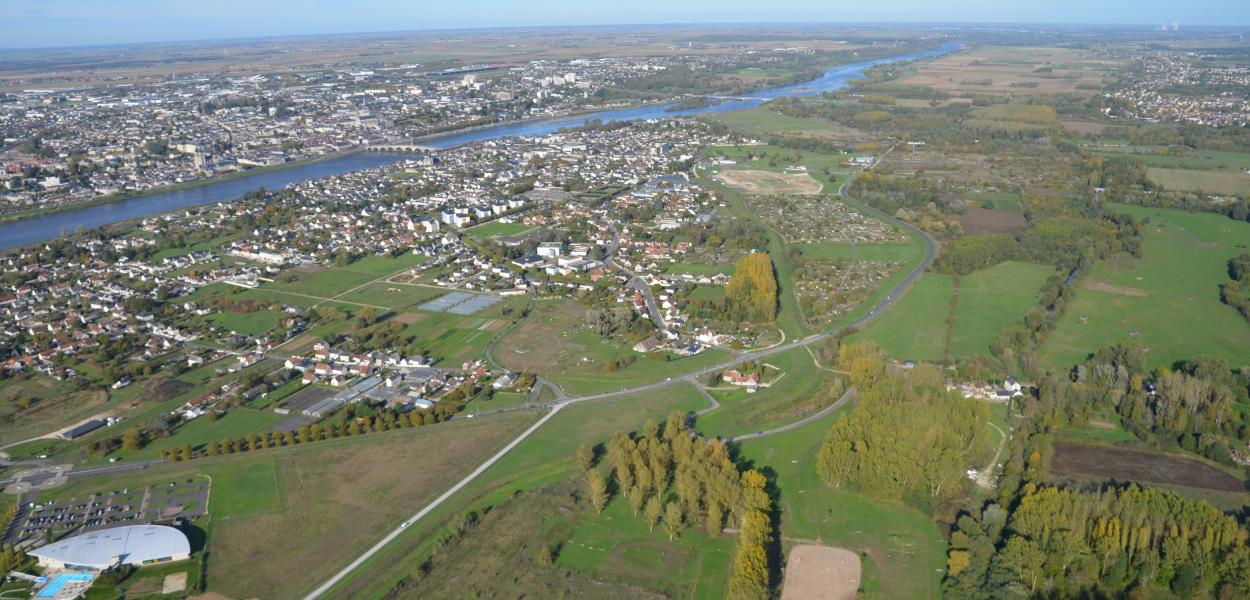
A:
[[740, 405, 946, 599]]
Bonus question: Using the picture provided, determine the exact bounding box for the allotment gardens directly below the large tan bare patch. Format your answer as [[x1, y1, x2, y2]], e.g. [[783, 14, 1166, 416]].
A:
[[746, 195, 908, 244]]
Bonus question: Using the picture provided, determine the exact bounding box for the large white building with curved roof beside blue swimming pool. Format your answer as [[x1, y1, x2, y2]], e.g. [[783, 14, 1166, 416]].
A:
[[28, 525, 191, 571]]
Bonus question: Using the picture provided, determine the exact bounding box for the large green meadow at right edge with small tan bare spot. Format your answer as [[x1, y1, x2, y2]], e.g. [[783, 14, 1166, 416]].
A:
[[1041, 205, 1250, 370]]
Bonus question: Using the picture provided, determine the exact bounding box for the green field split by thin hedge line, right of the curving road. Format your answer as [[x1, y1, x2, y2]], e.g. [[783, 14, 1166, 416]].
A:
[[858, 263, 1051, 361]]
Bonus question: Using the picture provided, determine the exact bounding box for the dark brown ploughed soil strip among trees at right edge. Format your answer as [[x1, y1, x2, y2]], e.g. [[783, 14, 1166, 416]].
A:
[[1050, 441, 1245, 493]]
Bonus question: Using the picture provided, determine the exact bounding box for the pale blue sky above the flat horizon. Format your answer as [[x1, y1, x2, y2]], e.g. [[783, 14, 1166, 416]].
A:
[[0, 0, 1250, 48]]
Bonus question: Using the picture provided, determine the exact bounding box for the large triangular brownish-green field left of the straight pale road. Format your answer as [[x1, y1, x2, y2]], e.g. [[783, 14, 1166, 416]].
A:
[[36, 414, 535, 598]]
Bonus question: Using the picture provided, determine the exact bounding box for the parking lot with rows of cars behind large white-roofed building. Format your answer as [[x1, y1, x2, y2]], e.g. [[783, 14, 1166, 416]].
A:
[[5, 479, 209, 544]]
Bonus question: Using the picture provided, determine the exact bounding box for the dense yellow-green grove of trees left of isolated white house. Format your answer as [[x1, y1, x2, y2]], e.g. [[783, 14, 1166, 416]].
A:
[[818, 341, 989, 506]]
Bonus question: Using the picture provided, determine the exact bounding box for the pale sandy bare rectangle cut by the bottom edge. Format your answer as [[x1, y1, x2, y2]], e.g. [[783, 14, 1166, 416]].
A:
[[781, 545, 860, 600]]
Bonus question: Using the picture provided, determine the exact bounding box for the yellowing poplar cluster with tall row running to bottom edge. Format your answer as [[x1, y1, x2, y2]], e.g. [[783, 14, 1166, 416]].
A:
[[576, 411, 774, 600]]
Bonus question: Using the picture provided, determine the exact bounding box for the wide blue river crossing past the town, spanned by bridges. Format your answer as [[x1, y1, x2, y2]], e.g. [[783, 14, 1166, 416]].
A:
[[0, 44, 960, 250]]
